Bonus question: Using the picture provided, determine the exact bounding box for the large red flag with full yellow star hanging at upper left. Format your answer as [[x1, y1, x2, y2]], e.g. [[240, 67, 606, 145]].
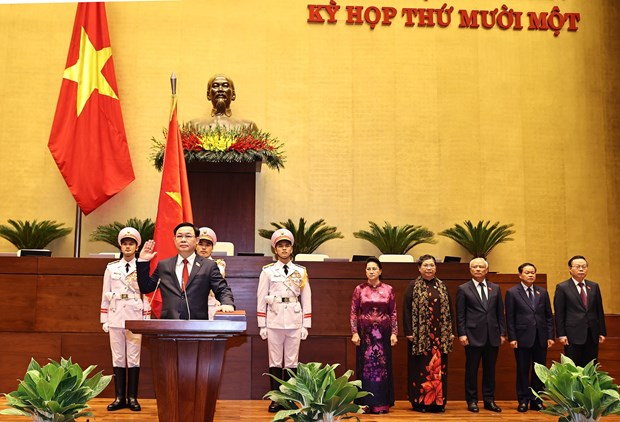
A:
[[48, 3, 135, 215]]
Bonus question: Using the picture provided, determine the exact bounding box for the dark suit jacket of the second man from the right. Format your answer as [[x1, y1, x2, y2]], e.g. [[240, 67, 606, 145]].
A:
[[506, 283, 554, 349]]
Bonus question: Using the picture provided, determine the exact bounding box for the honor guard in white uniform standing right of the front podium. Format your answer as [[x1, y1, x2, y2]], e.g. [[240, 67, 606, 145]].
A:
[[256, 229, 312, 413]]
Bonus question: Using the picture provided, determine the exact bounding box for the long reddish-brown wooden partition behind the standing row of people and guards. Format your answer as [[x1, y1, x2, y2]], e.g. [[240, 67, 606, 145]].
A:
[[0, 257, 620, 406]]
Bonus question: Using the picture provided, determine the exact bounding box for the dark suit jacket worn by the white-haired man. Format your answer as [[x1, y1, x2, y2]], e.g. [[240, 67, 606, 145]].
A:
[[456, 280, 506, 347]]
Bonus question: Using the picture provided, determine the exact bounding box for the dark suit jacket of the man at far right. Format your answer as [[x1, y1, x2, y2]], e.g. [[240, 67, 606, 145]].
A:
[[553, 278, 607, 344]]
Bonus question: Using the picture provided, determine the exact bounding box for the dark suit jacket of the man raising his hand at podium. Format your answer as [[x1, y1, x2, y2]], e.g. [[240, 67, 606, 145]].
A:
[[136, 255, 235, 319]]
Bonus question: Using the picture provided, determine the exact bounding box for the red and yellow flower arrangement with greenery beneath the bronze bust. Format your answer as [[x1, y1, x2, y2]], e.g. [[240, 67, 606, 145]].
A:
[[151, 122, 286, 171]]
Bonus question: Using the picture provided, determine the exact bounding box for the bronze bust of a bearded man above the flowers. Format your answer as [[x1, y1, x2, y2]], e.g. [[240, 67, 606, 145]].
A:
[[192, 74, 256, 129]]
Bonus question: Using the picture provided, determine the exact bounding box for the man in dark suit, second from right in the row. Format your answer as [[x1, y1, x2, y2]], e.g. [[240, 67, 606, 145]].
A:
[[506, 262, 555, 412]]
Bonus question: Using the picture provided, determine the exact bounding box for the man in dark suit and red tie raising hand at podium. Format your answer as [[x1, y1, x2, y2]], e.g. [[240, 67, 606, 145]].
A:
[[136, 223, 235, 319]]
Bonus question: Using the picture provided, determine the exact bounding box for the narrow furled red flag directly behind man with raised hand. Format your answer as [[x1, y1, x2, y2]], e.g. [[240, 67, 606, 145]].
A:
[[151, 90, 194, 318]]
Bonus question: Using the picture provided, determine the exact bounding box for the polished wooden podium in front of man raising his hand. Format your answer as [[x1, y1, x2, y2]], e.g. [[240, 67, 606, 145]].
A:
[[125, 311, 247, 422]]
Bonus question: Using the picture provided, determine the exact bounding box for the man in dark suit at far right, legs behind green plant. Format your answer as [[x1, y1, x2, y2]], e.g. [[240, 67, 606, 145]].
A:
[[553, 255, 607, 367]]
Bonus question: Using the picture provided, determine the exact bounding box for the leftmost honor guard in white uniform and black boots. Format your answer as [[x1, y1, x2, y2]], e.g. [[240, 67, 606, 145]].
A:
[[101, 227, 150, 411]]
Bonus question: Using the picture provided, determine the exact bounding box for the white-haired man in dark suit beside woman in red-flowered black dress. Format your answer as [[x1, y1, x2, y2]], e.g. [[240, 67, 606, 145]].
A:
[[456, 258, 506, 412]]
